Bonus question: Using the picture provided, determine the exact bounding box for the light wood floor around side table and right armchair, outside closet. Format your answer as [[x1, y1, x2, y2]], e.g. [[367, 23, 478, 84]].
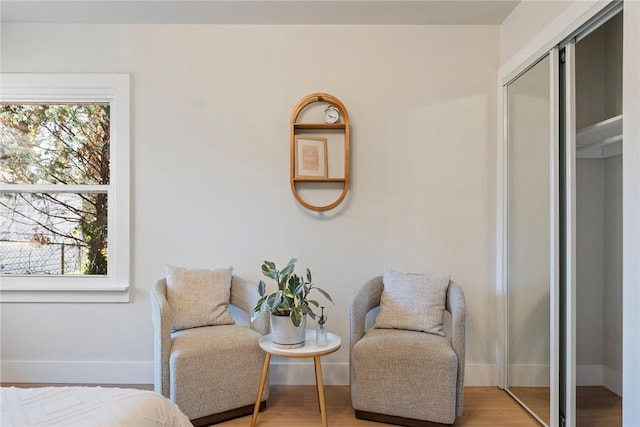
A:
[[217, 386, 540, 427]]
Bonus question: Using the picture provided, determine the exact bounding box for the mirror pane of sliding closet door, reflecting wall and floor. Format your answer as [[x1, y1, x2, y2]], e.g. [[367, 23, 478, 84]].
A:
[[507, 56, 551, 425]]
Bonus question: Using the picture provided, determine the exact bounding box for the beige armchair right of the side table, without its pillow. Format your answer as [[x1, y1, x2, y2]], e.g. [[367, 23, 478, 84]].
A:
[[350, 277, 466, 426]]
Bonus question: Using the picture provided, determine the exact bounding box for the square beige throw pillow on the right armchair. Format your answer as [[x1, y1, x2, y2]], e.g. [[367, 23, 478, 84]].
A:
[[375, 270, 449, 336]]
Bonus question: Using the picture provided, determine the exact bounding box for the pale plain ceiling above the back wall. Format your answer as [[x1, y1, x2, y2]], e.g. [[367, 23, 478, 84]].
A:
[[0, 0, 519, 25]]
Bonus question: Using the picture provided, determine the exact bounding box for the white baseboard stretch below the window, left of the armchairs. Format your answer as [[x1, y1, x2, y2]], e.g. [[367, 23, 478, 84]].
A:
[[0, 360, 153, 384]]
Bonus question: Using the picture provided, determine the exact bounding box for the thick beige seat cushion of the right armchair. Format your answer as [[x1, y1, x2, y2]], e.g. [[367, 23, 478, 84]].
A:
[[351, 329, 458, 425]]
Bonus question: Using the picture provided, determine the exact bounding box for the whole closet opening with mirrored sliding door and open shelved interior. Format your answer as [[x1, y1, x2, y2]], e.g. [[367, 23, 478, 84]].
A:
[[502, 2, 624, 427]]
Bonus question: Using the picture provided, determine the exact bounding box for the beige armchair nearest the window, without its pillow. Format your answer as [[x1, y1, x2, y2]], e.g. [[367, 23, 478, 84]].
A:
[[151, 276, 269, 426]]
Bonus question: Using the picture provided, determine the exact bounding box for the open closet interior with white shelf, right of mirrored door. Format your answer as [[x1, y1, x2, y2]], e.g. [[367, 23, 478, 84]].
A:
[[575, 12, 624, 427]]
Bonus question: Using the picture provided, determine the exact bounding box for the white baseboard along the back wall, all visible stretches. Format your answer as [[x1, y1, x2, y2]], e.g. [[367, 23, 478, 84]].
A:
[[0, 359, 496, 387]]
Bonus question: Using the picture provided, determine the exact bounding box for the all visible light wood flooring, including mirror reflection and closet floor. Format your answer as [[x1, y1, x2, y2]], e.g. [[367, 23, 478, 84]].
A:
[[0, 383, 622, 427]]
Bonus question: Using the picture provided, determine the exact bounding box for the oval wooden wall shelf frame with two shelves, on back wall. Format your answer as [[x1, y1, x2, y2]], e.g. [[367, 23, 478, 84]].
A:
[[290, 93, 350, 212]]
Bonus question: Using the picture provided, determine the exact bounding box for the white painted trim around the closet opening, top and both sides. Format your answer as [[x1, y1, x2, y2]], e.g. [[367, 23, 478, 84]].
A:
[[496, 0, 640, 425]]
